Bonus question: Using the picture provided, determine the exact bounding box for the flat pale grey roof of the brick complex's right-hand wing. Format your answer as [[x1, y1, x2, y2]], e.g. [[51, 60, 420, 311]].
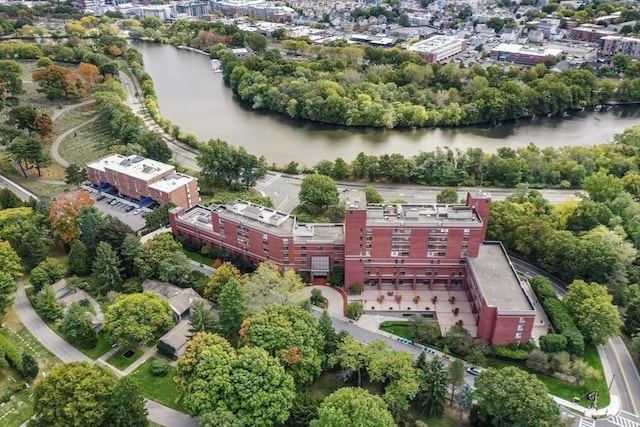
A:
[[467, 242, 534, 313]]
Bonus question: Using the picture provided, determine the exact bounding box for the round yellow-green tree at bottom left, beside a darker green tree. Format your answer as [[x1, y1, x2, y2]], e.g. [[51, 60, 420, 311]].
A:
[[29, 362, 118, 427]]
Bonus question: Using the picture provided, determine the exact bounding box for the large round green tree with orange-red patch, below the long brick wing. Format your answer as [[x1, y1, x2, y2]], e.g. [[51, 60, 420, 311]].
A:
[[240, 305, 324, 385]]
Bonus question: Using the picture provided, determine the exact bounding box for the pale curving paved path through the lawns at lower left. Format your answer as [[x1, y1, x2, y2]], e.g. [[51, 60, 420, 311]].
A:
[[14, 279, 198, 427]]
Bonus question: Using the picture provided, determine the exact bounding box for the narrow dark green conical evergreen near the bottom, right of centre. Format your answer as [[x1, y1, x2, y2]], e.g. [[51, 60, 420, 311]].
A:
[[416, 357, 447, 418]]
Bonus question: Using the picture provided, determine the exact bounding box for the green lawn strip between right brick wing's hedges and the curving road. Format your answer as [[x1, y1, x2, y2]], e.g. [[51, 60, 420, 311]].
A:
[[489, 345, 609, 408]]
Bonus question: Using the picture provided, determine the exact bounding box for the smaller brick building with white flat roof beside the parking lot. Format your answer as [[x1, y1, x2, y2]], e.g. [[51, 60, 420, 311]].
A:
[[87, 154, 200, 208]]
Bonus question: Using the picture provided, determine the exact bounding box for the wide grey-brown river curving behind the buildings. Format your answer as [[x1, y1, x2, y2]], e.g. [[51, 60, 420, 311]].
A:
[[134, 43, 640, 166]]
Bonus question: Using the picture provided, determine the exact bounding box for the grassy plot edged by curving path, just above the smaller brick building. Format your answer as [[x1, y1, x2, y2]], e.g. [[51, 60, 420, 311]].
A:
[[58, 119, 113, 165]]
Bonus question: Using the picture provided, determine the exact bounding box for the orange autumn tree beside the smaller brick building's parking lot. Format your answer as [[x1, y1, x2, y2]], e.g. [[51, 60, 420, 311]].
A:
[[49, 191, 93, 244]]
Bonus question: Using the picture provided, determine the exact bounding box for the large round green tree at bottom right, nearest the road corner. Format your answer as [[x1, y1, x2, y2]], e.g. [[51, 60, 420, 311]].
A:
[[474, 366, 560, 427]]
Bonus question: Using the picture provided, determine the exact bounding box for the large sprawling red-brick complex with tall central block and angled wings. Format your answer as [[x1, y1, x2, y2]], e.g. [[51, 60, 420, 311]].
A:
[[169, 191, 535, 345]]
